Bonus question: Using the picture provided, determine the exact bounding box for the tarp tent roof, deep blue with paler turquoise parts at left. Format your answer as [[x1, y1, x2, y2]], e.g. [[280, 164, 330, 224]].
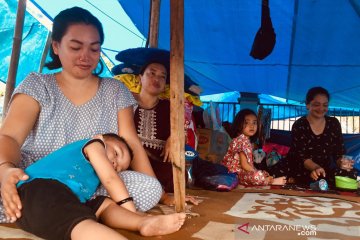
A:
[[0, 0, 360, 108]]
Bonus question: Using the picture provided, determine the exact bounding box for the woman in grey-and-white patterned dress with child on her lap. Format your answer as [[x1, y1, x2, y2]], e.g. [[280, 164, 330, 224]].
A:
[[0, 7, 176, 239]]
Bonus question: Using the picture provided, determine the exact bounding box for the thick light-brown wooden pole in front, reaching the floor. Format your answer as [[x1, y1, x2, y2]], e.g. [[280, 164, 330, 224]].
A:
[[170, 0, 185, 212]]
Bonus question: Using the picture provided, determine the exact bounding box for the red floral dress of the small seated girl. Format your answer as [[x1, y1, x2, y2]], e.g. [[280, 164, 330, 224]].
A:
[[222, 134, 269, 185]]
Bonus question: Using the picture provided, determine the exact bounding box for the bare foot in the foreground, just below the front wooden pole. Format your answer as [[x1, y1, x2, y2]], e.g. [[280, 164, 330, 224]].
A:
[[139, 213, 186, 237]]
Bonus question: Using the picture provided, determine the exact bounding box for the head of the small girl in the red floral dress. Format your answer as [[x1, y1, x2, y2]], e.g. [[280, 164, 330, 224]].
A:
[[231, 108, 258, 138]]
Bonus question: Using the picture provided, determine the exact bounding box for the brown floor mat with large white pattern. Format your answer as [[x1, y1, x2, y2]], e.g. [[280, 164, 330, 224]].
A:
[[0, 188, 360, 240]]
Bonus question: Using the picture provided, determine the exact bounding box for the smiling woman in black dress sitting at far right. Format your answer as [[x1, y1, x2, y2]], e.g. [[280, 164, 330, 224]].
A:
[[288, 87, 356, 185]]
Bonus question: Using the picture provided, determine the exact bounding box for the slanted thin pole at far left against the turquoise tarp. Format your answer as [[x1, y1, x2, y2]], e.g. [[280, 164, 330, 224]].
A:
[[3, 0, 26, 119]]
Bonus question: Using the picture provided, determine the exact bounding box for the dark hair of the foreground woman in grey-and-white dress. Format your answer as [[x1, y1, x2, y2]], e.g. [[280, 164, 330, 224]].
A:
[[45, 7, 104, 76]]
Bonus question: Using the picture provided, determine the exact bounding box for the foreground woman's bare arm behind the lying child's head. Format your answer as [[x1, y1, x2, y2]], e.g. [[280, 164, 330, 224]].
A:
[[118, 107, 156, 178]]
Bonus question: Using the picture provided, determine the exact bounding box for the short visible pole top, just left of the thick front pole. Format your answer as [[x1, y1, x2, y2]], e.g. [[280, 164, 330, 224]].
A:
[[149, 0, 161, 48]]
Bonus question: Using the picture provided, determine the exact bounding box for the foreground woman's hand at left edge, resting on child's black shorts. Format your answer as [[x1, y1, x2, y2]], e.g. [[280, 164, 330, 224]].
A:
[[1, 168, 29, 223]]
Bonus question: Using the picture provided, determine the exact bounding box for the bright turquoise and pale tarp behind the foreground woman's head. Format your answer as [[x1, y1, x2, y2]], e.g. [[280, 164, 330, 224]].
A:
[[0, 0, 146, 84]]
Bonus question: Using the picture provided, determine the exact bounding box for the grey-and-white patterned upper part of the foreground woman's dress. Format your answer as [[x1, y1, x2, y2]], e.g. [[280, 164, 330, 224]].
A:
[[13, 73, 136, 168]]
